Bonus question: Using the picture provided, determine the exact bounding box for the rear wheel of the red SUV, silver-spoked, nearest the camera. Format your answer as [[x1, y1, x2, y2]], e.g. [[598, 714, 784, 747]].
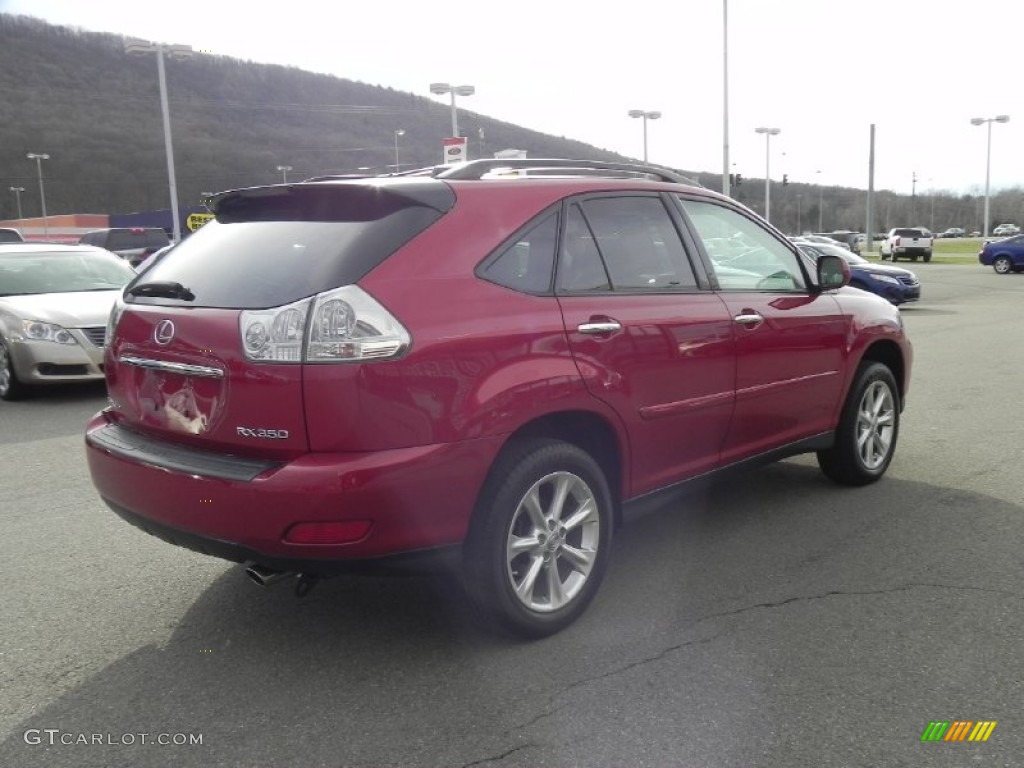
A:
[[463, 439, 612, 638]]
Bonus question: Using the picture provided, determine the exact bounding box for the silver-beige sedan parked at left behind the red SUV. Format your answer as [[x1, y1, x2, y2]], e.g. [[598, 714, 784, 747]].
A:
[[0, 243, 135, 400]]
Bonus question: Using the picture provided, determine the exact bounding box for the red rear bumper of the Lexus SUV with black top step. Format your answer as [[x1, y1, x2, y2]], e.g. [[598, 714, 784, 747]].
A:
[[86, 414, 502, 573]]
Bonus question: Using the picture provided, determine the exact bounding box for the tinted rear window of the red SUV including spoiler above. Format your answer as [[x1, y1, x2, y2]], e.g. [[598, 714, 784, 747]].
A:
[[128, 182, 454, 309]]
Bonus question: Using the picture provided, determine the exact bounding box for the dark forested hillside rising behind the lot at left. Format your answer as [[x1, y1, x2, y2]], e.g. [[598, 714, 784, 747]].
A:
[[0, 14, 627, 219]]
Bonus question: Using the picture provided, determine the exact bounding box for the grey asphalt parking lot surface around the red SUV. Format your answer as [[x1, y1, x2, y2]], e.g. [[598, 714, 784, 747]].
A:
[[0, 263, 1024, 768]]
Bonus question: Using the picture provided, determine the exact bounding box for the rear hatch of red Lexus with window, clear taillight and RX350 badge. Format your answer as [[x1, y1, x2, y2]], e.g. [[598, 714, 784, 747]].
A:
[[106, 179, 455, 459]]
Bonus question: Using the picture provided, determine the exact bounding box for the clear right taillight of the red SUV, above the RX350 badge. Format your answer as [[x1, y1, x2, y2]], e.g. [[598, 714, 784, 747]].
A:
[[240, 286, 411, 362]]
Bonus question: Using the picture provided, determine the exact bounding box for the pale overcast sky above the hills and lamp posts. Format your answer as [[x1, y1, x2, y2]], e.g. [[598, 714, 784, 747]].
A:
[[0, 0, 1024, 194]]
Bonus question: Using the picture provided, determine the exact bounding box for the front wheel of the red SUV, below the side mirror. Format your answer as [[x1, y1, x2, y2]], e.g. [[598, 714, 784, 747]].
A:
[[818, 361, 900, 485]]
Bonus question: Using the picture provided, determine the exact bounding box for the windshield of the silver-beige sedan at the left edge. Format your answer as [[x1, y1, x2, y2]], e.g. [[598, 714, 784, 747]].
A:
[[0, 252, 135, 296]]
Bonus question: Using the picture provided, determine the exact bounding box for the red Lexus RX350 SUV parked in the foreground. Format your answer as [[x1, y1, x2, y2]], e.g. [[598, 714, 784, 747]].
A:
[[86, 160, 911, 637]]
